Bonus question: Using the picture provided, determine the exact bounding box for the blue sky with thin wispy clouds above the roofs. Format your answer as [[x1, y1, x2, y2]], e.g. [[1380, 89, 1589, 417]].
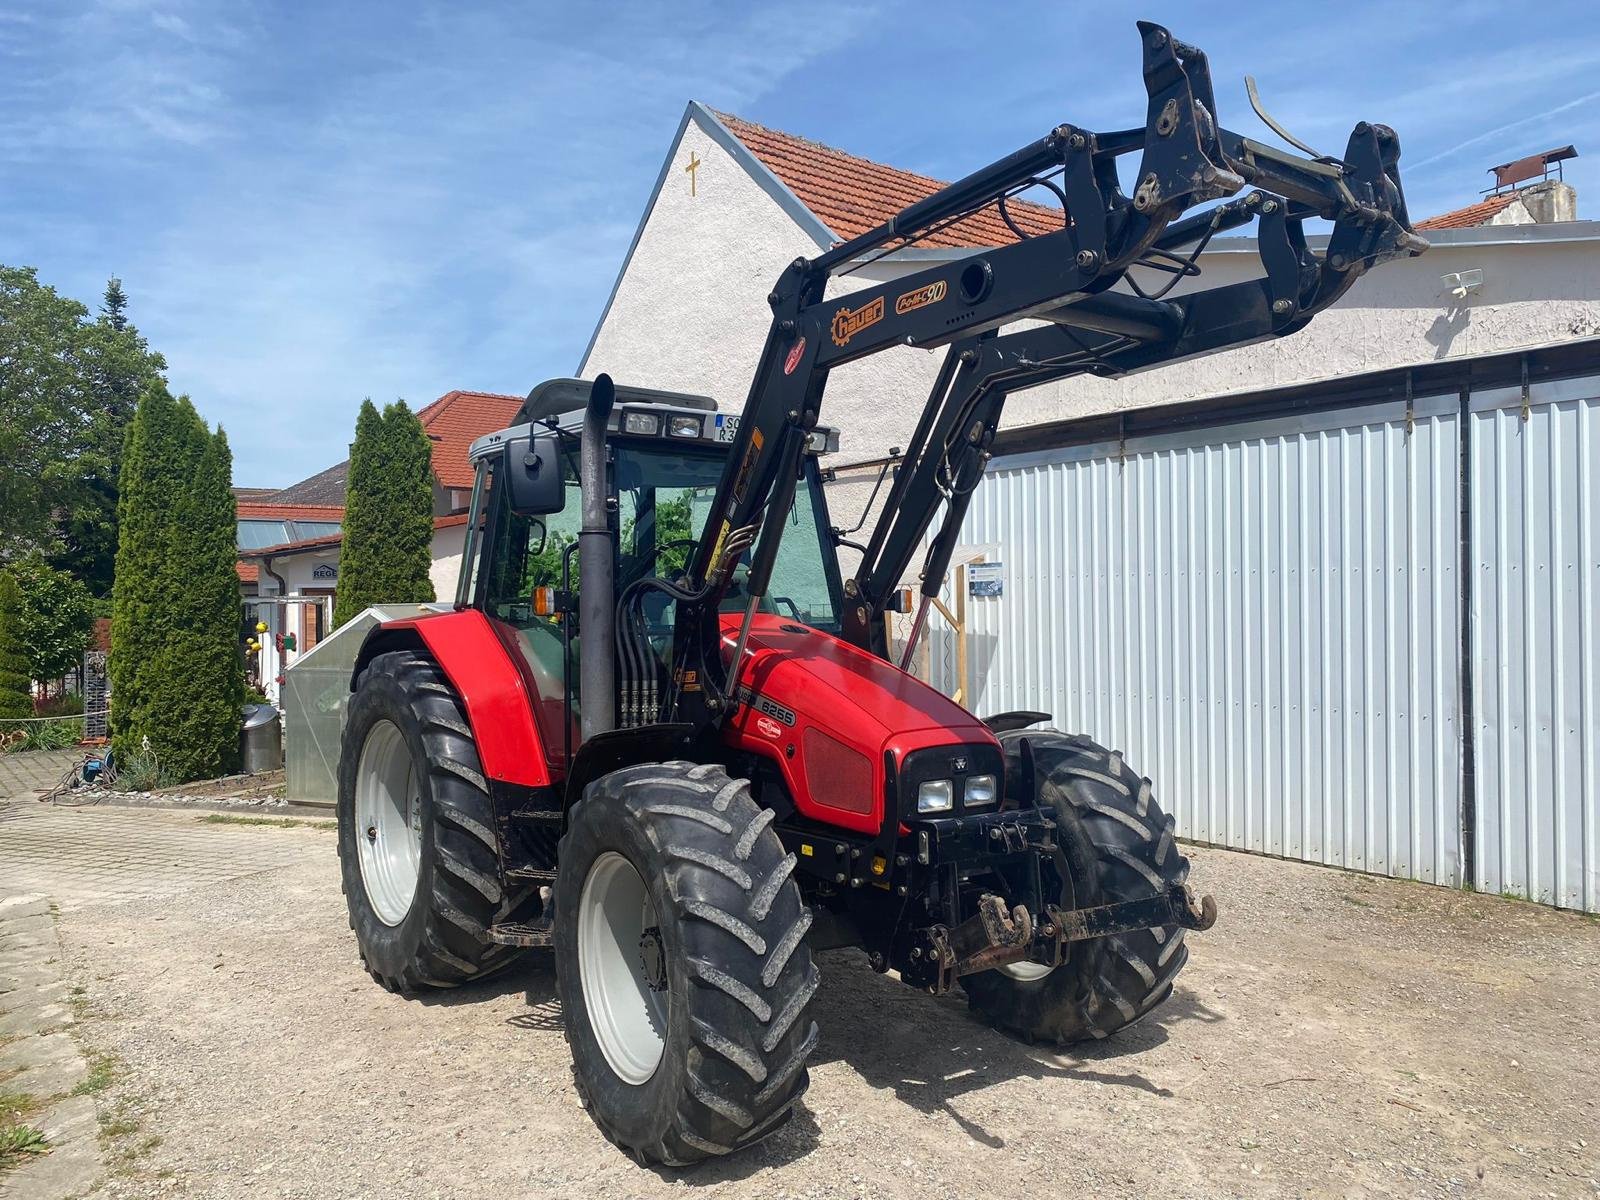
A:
[[0, 0, 1600, 485]]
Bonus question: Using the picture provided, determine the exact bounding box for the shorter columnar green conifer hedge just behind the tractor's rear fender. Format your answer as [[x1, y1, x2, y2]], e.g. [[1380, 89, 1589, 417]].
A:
[[333, 400, 434, 626]]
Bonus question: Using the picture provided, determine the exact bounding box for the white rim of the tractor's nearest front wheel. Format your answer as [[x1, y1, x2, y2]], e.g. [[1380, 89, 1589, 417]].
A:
[[578, 851, 667, 1086]]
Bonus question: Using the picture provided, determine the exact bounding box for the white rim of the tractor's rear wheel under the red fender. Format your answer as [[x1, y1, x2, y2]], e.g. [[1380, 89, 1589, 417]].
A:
[[355, 720, 422, 925]]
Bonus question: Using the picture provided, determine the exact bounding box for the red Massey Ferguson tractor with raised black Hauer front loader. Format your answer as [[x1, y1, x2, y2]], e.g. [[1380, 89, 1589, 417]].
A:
[[339, 24, 1427, 1165]]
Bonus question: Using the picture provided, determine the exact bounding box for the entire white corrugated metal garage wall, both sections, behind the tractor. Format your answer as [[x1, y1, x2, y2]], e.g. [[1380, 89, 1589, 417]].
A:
[[933, 371, 1600, 910]]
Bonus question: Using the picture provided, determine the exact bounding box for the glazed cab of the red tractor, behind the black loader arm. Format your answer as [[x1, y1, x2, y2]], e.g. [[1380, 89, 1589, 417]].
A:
[[456, 379, 842, 762]]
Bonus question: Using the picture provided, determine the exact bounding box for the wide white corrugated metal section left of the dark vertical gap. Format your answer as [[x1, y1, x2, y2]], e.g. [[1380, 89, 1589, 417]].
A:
[[962, 397, 1461, 883]]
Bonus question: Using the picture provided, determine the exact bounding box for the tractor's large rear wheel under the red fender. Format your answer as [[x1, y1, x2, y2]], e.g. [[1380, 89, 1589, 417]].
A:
[[338, 651, 542, 994]]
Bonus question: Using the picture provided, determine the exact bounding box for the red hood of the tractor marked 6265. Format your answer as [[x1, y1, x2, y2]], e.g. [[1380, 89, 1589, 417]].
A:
[[722, 614, 997, 832]]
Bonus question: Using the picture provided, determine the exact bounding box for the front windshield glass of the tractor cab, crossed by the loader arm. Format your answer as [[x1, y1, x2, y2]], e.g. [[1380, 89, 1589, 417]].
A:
[[614, 443, 838, 632]]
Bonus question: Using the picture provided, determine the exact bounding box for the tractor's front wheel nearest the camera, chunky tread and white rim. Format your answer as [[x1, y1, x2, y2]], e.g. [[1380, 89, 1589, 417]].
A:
[[555, 762, 819, 1166]]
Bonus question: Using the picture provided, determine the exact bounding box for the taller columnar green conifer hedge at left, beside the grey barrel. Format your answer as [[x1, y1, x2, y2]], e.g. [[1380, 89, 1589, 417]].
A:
[[110, 382, 245, 781]]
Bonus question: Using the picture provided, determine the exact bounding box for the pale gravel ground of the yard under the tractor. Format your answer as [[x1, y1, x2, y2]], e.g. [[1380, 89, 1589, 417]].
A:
[[50, 827, 1600, 1200]]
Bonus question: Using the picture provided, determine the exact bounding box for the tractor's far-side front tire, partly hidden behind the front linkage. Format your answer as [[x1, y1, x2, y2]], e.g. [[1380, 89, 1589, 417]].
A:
[[962, 730, 1189, 1043]]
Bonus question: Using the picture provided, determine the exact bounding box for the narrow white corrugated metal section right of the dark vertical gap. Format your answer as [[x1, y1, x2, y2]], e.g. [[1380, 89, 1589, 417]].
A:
[[1470, 379, 1600, 912]]
